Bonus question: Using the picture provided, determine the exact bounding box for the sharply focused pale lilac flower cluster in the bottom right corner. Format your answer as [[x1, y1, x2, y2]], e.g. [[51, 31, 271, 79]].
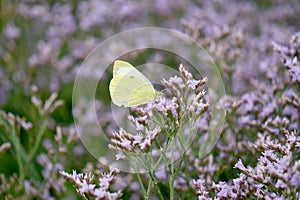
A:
[[235, 130, 300, 197]]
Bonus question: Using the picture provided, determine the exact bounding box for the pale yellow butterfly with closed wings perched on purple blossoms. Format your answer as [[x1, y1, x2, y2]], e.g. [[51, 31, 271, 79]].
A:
[[109, 60, 162, 107]]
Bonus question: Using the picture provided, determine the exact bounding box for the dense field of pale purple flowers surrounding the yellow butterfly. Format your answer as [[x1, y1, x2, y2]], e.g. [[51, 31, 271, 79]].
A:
[[0, 0, 300, 199]]
